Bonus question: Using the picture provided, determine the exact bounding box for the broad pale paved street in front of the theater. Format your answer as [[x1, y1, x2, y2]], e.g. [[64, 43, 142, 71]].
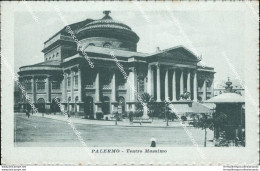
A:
[[14, 113, 213, 147]]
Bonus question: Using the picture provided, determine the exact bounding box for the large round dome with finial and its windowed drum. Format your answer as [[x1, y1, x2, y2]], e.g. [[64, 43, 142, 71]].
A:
[[77, 11, 139, 51]]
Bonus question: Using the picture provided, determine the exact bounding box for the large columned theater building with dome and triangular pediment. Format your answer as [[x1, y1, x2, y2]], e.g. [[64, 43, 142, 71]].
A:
[[18, 11, 215, 116]]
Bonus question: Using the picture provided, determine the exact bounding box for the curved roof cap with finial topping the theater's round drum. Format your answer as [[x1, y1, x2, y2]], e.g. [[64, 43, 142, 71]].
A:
[[77, 11, 139, 43]]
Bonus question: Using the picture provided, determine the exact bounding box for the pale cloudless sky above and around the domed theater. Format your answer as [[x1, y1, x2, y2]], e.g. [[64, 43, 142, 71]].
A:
[[14, 8, 248, 81]]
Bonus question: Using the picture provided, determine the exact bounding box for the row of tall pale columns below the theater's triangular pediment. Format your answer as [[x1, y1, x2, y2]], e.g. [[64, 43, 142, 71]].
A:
[[147, 64, 197, 102]]
